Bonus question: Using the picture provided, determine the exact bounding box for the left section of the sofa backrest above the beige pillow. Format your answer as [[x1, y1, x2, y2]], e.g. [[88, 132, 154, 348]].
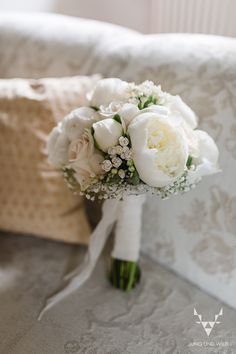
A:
[[0, 13, 140, 78]]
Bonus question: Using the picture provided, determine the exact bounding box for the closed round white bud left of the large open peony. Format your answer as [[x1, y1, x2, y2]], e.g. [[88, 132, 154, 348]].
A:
[[93, 118, 123, 152]]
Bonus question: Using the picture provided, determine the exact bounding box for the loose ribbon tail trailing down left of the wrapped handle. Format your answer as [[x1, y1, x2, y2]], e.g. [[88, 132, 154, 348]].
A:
[[38, 200, 119, 321]]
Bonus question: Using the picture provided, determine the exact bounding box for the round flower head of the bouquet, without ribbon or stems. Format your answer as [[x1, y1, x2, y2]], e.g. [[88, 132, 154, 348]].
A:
[[48, 78, 219, 200]]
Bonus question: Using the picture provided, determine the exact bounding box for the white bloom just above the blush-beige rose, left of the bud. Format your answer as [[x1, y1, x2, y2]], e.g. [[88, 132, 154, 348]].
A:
[[62, 107, 98, 141]]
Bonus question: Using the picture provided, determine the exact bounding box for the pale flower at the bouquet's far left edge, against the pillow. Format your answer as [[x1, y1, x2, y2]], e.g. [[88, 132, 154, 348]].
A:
[[47, 123, 70, 167]]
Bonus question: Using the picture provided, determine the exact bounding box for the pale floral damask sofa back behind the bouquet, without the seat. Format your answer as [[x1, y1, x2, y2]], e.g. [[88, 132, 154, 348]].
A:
[[0, 15, 236, 308]]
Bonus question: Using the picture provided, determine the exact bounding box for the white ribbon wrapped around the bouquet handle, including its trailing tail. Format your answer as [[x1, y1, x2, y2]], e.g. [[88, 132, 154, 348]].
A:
[[38, 195, 146, 320]]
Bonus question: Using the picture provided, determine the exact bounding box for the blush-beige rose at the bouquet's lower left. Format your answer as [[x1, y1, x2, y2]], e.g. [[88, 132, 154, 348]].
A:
[[68, 131, 104, 188]]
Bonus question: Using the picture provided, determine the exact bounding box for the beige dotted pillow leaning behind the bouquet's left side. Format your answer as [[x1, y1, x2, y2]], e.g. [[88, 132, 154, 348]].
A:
[[0, 76, 99, 243]]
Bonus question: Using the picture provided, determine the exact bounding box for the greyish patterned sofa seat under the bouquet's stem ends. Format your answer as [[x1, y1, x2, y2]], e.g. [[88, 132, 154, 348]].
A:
[[0, 233, 236, 354]]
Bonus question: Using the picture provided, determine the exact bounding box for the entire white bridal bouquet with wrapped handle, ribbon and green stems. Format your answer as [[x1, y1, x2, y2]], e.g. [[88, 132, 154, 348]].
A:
[[39, 78, 218, 318]]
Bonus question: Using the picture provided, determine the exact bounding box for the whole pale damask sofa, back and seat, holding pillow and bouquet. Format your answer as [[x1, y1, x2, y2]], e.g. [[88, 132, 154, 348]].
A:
[[0, 14, 236, 354]]
